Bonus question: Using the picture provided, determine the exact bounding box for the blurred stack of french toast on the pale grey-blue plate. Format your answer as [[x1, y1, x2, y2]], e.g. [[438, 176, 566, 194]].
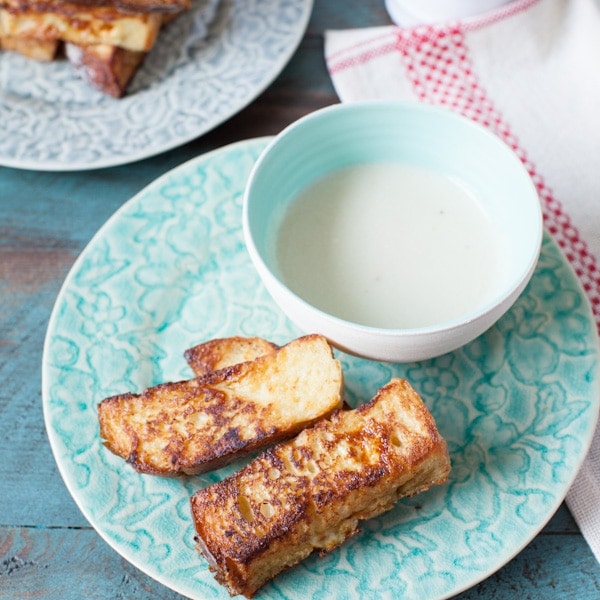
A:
[[0, 0, 191, 98]]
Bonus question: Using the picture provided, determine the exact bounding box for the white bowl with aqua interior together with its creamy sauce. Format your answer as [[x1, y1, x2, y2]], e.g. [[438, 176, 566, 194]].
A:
[[243, 101, 543, 362]]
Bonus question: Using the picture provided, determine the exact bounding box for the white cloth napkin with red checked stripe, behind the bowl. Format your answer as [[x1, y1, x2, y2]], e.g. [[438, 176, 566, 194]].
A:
[[325, 0, 600, 561]]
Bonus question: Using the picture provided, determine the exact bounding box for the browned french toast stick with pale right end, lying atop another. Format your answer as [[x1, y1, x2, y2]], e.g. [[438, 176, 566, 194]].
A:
[[98, 335, 343, 476]]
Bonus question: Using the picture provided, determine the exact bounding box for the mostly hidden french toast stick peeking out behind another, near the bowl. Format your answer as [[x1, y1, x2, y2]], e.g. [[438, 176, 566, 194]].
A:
[[183, 335, 278, 377]]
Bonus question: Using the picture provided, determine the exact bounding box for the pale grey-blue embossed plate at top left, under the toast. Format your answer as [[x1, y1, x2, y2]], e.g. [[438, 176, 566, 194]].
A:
[[0, 0, 313, 171]]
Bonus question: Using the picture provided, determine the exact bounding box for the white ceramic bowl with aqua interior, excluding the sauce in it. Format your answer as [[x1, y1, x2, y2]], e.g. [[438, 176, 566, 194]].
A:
[[243, 101, 543, 362]]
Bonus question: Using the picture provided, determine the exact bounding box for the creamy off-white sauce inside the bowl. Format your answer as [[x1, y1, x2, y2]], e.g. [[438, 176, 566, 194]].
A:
[[275, 163, 501, 328]]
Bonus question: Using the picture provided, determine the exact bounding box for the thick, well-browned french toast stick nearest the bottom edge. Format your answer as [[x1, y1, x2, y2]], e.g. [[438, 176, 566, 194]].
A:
[[191, 379, 450, 598]]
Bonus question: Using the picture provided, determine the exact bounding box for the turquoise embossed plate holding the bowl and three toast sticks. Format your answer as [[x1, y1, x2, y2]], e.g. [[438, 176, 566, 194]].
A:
[[43, 139, 600, 600]]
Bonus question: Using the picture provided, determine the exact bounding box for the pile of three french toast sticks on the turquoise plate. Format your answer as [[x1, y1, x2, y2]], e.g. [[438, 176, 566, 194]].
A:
[[98, 335, 450, 598]]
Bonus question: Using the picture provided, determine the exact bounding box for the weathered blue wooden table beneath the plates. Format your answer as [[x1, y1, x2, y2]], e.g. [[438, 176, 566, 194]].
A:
[[0, 0, 600, 600]]
